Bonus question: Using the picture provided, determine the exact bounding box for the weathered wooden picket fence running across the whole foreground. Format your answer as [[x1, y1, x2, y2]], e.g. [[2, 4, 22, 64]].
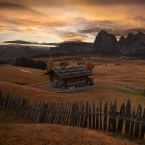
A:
[[0, 90, 145, 139]]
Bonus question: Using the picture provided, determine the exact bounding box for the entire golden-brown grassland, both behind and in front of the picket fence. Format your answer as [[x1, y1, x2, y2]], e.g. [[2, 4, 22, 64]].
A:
[[0, 58, 145, 145]]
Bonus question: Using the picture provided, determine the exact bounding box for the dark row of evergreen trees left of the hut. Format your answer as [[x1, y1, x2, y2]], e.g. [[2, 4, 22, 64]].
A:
[[13, 57, 46, 70]]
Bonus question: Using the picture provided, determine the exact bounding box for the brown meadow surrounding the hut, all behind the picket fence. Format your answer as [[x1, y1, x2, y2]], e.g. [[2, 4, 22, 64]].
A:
[[0, 61, 145, 108]]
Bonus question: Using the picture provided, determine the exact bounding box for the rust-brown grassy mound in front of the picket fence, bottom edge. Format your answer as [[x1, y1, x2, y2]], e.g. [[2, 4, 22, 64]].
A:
[[0, 124, 137, 145]]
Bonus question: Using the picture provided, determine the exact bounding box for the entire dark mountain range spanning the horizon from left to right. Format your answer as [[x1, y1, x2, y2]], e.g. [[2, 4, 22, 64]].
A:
[[0, 30, 145, 59]]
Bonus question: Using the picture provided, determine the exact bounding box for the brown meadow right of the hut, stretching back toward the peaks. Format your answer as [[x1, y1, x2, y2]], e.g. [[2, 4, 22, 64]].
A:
[[33, 56, 145, 87]]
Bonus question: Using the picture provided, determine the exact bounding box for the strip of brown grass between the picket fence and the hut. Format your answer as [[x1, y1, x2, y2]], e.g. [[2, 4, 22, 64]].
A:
[[0, 81, 145, 108]]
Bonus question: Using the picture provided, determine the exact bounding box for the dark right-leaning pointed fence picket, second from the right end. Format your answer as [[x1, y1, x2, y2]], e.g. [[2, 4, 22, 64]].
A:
[[134, 105, 142, 138]]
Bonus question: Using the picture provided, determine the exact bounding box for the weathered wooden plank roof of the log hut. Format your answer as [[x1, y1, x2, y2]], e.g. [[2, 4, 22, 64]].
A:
[[44, 66, 92, 79]]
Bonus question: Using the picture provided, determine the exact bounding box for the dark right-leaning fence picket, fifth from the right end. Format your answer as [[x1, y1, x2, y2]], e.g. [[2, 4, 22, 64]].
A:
[[117, 103, 125, 132]]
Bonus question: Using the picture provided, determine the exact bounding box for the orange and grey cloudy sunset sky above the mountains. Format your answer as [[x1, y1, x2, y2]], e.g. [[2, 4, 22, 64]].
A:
[[0, 0, 145, 43]]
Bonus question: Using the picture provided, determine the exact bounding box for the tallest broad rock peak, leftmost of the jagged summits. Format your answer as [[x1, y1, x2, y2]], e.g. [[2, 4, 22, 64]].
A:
[[94, 30, 118, 55]]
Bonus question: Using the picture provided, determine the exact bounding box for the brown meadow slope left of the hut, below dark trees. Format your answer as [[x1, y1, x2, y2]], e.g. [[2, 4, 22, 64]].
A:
[[0, 65, 48, 84]]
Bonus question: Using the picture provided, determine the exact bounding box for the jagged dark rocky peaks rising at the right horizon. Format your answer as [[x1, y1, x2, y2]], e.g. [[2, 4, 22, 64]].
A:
[[93, 30, 145, 55]]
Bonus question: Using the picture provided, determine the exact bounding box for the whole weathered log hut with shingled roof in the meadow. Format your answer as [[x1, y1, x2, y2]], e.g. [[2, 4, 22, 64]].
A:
[[44, 66, 93, 88]]
